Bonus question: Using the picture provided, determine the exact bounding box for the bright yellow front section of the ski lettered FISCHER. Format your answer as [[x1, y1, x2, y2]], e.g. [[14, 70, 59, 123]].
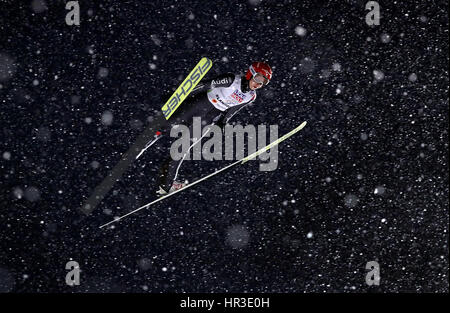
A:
[[161, 58, 212, 120]]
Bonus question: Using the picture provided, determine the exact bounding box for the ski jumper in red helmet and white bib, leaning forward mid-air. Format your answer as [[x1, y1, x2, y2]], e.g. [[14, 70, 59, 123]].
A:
[[157, 62, 272, 195]]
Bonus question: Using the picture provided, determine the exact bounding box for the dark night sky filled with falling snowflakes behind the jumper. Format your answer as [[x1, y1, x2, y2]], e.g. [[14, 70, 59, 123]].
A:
[[0, 0, 449, 293]]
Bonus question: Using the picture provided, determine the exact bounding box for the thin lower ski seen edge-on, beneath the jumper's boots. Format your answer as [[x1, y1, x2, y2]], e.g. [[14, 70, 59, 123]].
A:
[[100, 121, 306, 228]]
